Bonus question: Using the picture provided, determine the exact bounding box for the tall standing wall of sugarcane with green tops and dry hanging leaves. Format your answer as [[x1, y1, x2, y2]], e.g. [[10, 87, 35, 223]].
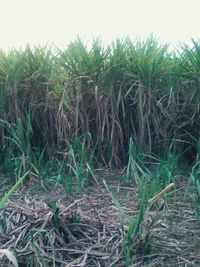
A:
[[0, 36, 200, 178]]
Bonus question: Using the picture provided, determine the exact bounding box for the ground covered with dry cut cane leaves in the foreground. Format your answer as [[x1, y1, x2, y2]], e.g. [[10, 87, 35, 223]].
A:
[[0, 171, 200, 267]]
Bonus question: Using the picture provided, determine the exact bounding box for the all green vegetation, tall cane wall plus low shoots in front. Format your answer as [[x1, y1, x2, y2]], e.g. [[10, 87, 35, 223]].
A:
[[0, 36, 200, 266]]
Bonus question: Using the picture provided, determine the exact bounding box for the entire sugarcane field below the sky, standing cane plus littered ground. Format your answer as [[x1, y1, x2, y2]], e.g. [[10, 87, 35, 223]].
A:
[[0, 35, 200, 267]]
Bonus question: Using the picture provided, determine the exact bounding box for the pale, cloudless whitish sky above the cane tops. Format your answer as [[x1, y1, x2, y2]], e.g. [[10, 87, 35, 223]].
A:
[[0, 0, 200, 50]]
